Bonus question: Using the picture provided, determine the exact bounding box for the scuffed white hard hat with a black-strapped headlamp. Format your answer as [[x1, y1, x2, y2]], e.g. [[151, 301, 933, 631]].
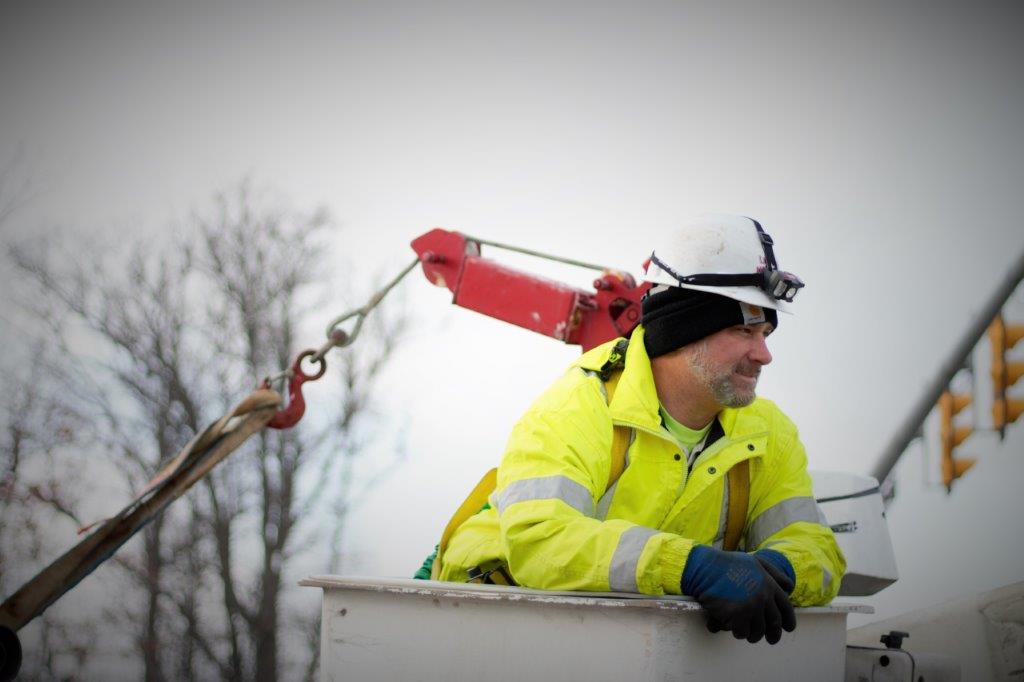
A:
[[641, 213, 804, 312]]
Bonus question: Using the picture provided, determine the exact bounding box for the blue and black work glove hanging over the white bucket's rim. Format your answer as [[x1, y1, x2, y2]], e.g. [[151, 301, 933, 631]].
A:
[[681, 545, 797, 644]]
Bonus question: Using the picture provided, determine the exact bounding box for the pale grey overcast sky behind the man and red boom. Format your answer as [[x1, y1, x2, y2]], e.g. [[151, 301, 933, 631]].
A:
[[0, 2, 1024, 638]]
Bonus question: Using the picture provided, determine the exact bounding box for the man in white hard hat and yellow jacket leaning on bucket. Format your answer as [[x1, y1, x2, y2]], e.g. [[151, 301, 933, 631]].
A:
[[434, 215, 846, 644]]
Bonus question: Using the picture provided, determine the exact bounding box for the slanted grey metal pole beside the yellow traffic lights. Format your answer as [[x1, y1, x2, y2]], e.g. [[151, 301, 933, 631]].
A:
[[871, 253, 1024, 482]]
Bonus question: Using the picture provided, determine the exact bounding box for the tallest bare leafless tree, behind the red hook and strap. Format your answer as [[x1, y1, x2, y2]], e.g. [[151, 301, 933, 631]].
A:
[[11, 182, 403, 681]]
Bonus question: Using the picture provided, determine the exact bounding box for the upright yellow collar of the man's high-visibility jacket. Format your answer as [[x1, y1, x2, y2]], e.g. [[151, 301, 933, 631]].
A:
[[572, 325, 768, 444]]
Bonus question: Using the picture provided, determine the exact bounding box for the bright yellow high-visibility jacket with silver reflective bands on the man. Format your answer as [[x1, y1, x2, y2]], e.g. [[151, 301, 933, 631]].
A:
[[438, 327, 846, 606]]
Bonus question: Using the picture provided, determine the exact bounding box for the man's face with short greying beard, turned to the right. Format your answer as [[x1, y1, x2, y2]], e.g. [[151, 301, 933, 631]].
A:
[[687, 323, 773, 408]]
